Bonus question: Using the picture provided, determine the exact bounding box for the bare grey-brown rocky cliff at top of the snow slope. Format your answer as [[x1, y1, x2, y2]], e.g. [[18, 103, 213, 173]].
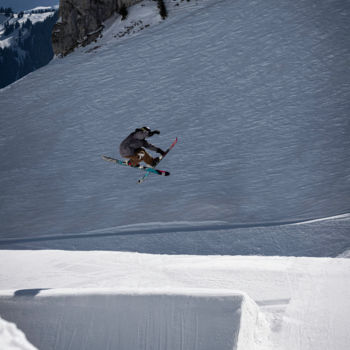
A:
[[52, 0, 140, 56]]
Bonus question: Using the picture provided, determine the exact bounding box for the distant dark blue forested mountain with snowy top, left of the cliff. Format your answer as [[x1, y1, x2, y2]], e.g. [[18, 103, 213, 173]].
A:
[[0, 7, 58, 88]]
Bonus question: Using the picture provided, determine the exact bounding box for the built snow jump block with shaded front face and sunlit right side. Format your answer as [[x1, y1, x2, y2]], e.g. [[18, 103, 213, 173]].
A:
[[0, 289, 259, 350]]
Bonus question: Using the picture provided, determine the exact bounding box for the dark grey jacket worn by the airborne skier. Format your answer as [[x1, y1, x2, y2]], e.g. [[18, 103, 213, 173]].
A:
[[119, 129, 159, 157]]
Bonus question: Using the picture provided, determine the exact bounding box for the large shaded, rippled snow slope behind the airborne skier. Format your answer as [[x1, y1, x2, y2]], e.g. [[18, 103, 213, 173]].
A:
[[0, 1, 350, 237]]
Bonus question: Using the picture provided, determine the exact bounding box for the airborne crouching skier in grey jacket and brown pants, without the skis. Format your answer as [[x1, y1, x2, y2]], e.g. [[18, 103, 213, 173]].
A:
[[119, 126, 165, 167]]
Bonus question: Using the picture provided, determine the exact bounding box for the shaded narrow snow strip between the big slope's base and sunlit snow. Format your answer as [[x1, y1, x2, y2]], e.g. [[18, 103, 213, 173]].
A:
[[0, 218, 350, 257]]
